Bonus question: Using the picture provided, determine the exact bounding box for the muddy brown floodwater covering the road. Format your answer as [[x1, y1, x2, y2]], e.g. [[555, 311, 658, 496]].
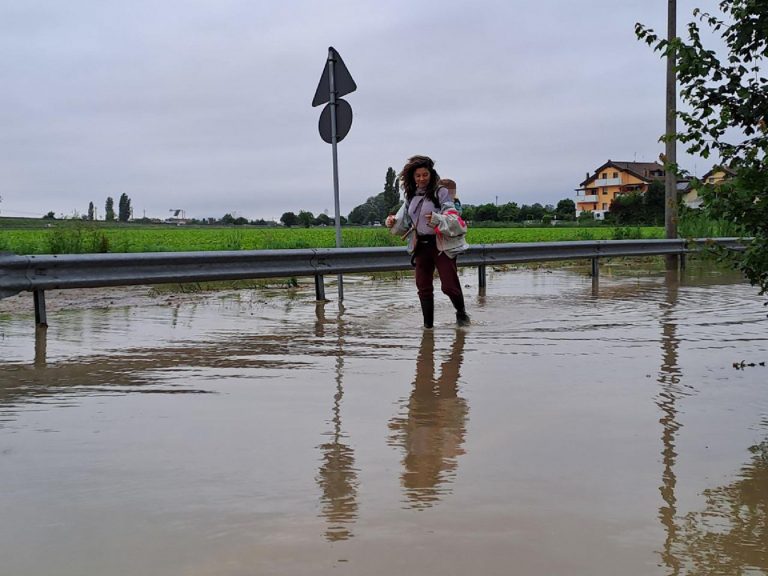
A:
[[0, 268, 768, 576]]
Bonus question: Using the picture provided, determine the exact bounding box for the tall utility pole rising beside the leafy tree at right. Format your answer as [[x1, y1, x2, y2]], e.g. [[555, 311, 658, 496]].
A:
[[664, 0, 678, 270]]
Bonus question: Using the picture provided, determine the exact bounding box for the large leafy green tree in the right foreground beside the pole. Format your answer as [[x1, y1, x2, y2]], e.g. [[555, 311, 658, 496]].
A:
[[635, 0, 768, 294]]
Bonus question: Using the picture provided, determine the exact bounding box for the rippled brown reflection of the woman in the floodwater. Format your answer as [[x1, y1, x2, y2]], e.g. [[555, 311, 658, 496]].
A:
[[389, 330, 468, 508]]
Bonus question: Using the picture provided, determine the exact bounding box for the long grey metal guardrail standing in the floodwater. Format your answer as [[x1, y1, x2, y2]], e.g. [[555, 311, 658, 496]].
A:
[[0, 238, 747, 324]]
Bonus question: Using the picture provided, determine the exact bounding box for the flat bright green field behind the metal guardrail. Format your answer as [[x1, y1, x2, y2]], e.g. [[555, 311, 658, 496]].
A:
[[0, 219, 664, 254]]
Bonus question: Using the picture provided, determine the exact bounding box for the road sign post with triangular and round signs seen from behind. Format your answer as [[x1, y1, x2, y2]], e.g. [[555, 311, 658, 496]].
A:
[[312, 46, 357, 300]]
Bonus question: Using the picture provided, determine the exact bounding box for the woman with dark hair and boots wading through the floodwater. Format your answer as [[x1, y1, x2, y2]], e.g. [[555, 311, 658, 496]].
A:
[[386, 156, 469, 328]]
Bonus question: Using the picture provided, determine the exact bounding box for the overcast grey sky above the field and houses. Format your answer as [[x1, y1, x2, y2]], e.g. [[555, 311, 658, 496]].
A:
[[0, 0, 716, 219]]
